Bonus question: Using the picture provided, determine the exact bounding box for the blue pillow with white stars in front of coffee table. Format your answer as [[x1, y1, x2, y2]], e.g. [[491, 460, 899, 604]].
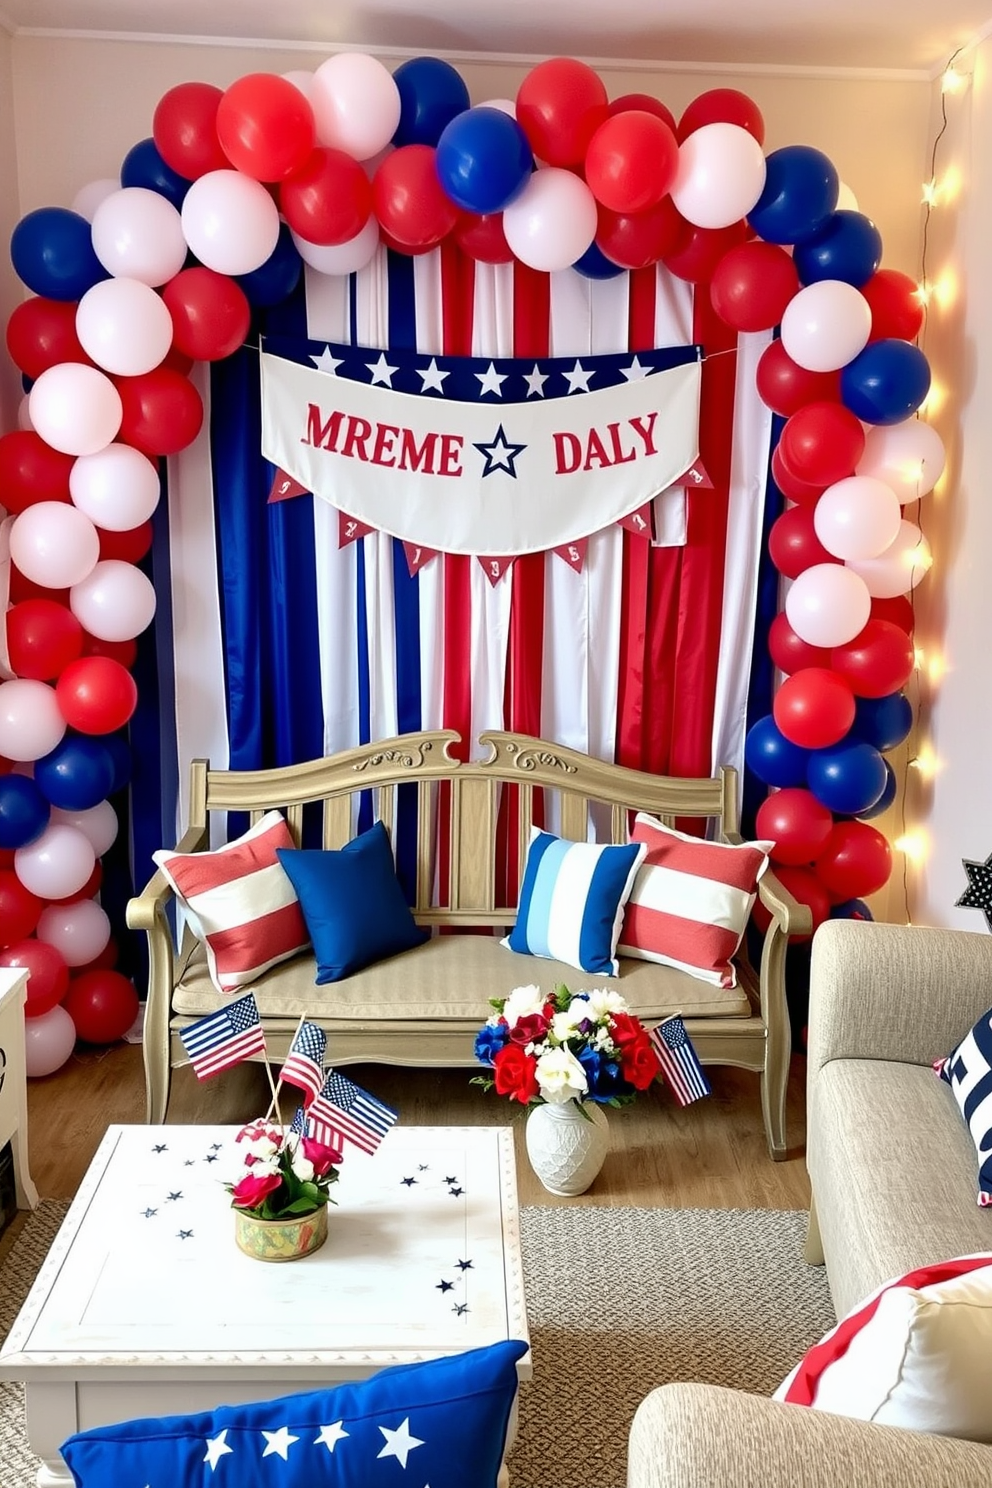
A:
[[61, 1339, 528, 1488]]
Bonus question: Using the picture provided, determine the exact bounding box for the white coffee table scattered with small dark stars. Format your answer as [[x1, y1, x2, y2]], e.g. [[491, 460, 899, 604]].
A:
[[0, 1126, 531, 1488]]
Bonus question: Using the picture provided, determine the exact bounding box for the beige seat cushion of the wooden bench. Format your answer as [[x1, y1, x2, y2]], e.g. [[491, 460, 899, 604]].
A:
[[173, 933, 751, 1031]]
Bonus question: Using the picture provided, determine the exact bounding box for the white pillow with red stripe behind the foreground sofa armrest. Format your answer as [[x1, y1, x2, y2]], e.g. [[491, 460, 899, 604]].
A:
[[775, 1251, 992, 1442]]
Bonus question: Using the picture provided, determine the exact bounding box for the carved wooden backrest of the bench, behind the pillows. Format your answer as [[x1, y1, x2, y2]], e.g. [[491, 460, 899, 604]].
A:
[[189, 731, 738, 926]]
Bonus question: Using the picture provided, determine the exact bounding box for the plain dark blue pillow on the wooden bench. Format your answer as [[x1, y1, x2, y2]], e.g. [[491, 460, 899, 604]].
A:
[[275, 821, 430, 987]]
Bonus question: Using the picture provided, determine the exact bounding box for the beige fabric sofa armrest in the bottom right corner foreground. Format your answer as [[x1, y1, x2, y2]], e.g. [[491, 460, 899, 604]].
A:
[[628, 1384, 992, 1488]]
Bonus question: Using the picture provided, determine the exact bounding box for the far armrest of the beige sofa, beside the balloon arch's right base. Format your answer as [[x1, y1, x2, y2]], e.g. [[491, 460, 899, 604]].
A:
[[809, 920, 992, 1079]]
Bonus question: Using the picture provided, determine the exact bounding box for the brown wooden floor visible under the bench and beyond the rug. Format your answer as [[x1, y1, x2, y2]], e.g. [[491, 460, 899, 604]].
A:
[[28, 1045, 809, 1208]]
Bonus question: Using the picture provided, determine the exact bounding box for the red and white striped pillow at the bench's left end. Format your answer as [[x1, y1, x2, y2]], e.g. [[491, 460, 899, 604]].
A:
[[152, 811, 309, 992]]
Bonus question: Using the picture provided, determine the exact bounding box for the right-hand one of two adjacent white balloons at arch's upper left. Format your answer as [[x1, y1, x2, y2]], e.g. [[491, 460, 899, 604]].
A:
[[183, 171, 280, 274]]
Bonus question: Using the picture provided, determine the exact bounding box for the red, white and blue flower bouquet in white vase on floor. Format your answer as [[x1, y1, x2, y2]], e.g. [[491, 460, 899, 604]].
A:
[[471, 984, 660, 1193]]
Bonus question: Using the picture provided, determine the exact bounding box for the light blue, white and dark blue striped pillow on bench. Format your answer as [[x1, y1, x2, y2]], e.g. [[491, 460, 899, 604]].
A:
[[503, 827, 647, 976]]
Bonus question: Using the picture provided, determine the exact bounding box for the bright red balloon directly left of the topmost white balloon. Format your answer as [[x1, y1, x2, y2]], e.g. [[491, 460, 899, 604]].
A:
[[216, 73, 315, 182]]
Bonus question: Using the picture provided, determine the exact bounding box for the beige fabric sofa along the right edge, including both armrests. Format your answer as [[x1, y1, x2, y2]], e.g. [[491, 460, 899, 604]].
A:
[[628, 921, 992, 1488]]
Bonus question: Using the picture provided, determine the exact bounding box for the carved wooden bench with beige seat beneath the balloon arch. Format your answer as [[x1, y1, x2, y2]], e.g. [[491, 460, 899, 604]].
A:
[[128, 731, 811, 1158]]
